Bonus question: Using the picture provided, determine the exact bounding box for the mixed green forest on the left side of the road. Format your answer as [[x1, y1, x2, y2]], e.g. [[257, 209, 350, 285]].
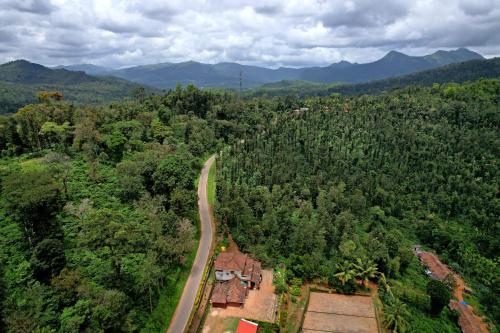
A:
[[0, 86, 250, 332]]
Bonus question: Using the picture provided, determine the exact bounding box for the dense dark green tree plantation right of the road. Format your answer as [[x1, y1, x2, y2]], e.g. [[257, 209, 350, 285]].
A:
[[216, 80, 500, 331]]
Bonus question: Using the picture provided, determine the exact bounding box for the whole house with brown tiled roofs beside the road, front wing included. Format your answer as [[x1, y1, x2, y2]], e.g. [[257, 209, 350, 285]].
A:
[[210, 251, 262, 308]]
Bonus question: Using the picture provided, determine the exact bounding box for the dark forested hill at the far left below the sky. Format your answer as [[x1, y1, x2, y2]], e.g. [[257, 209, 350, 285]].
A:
[[0, 60, 153, 114]]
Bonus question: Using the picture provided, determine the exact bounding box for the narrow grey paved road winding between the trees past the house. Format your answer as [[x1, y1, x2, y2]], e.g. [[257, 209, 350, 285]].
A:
[[167, 155, 215, 333]]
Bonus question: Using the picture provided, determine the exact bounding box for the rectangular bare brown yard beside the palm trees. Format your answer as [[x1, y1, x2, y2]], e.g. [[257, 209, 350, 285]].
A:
[[302, 292, 378, 333]]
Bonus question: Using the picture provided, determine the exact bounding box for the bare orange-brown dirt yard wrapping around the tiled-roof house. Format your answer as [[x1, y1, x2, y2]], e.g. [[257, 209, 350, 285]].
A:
[[203, 270, 277, 333]]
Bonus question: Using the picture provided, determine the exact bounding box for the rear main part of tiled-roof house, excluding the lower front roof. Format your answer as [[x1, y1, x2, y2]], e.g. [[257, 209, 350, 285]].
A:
[[214, 251, 262, 289]]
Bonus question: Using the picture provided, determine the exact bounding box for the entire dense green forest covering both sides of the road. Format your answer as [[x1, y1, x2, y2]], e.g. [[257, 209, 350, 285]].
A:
[[0, 80, 500, 332]]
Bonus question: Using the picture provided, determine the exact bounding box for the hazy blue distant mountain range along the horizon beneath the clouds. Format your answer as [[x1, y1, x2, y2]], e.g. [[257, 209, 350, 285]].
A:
[[59, 48, 484, 89]]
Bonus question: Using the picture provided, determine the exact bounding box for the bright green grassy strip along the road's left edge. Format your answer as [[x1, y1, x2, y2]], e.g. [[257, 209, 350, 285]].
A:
[[141, 240, 199, 333]]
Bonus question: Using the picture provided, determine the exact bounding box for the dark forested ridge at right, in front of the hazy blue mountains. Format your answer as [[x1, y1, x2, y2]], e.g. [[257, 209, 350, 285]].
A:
[[246, 58, 500, 97]]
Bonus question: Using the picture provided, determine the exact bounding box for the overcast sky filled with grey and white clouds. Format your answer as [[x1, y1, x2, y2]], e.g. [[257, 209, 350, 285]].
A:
[[0, 0, 500, 67]]
